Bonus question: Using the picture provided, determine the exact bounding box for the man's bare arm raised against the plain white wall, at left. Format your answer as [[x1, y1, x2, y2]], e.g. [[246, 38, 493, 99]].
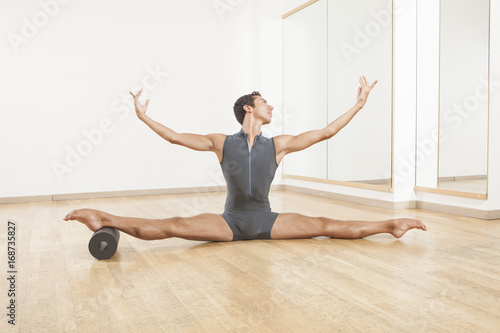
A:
[[130, 89, 225, 155]]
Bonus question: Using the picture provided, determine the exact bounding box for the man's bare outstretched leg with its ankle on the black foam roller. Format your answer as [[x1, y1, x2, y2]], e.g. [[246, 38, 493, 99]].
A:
[[64, 209, 233, 242]]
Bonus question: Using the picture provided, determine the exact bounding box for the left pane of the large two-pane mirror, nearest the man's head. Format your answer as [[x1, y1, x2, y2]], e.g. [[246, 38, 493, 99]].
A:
[[283, 0, 328, 179]]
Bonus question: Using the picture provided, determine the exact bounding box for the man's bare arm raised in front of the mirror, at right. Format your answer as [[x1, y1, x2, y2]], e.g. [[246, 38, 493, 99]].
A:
[[274, 76, 377, 159]]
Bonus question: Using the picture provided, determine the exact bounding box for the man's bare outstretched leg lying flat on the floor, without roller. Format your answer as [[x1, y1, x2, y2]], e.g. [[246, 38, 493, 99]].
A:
[[271, 213, 427, 239]]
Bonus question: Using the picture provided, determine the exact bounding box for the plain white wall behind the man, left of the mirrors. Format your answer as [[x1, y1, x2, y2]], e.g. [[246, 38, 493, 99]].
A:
[[0, 0, 282, 197]]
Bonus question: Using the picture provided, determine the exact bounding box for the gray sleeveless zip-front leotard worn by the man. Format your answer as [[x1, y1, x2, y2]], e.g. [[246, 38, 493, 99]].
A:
[[220, 129, 278, 241]]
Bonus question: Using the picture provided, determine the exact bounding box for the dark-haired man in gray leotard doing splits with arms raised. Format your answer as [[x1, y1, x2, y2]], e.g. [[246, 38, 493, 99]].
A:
[[64, 76, 426, 241]]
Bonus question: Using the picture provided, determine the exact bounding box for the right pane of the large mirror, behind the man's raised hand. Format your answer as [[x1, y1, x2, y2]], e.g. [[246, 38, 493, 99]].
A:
[[328, 0, 393, 188]]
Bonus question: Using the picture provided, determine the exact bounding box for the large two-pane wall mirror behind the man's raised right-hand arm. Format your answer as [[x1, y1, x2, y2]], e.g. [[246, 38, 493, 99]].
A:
[[283, 0, 394, 191]]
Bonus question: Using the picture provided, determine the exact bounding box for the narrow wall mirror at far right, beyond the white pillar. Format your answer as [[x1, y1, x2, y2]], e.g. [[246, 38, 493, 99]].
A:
[[438, 0, 490, 194]]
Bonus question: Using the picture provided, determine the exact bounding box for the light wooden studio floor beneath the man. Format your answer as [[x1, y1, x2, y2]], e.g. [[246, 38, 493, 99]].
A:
[[0, 191, 500, 332]]
